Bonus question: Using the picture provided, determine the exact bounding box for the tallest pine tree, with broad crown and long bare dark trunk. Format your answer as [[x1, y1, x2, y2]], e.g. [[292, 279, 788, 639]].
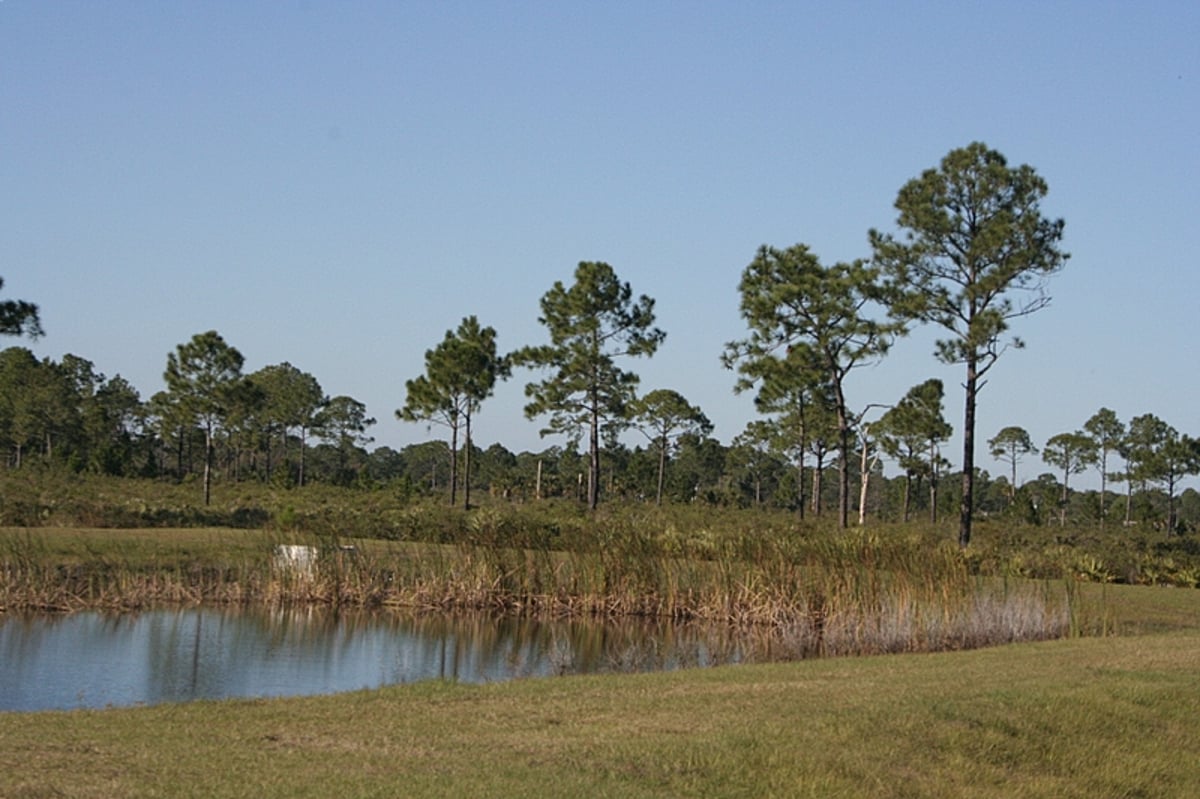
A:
[[870, 142, 1068, 546]]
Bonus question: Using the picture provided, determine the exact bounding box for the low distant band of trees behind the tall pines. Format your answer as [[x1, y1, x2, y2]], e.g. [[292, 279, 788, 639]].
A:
[[7, 347, 1200, 531]]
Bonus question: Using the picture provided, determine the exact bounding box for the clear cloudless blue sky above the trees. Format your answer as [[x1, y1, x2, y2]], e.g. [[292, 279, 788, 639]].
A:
[[0, 0, 1200, 479]]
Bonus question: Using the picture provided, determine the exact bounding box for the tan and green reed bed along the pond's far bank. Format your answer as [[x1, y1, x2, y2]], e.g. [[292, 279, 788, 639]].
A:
[[0, 515, 1096, 657]]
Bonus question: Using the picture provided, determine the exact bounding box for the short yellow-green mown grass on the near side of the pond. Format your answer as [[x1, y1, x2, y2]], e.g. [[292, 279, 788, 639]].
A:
[[0, 585, 1200, 799]]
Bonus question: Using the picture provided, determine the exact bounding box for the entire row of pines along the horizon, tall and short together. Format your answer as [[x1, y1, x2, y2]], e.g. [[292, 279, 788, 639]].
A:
[[23, 143, 1194, 537]]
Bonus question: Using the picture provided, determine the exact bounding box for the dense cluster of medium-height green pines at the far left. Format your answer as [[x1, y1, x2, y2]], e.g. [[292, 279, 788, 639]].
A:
[[0, 331, 374, 494]]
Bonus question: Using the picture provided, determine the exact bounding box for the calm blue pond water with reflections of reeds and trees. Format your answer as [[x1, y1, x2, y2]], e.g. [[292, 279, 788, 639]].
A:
[[0, 608, 778, 711]]
